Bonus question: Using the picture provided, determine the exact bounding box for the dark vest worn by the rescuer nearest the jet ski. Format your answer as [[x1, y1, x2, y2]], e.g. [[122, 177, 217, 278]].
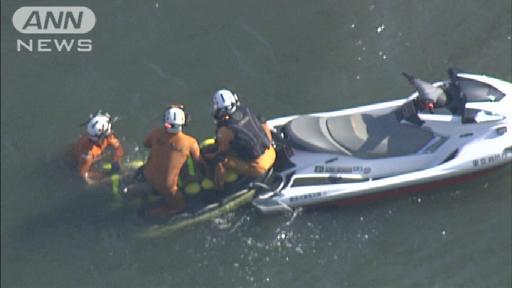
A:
[[218, 106, 271, 160]]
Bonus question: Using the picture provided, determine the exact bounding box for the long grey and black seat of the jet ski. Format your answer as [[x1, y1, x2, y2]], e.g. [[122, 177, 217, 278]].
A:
[[284, 111, 434, 158]]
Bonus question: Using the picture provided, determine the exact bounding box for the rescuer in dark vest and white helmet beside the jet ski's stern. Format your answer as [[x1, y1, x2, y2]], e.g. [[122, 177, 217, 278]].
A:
[[207, 89, 276, 190]]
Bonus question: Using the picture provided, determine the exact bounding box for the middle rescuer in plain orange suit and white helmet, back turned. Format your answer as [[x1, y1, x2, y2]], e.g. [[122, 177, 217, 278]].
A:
[[129, 105, 202, 218]]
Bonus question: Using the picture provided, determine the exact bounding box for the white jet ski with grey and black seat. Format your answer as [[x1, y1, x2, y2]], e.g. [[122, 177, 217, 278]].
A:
[[252, 69, 512, 213]]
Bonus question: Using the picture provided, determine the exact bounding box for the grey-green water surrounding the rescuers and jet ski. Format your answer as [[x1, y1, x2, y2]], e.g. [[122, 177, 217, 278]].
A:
[[1, 0, 512, 287]]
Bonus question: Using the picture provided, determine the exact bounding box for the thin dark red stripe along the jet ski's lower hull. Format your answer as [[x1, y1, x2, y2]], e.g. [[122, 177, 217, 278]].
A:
[[305, 164, 507, 208]]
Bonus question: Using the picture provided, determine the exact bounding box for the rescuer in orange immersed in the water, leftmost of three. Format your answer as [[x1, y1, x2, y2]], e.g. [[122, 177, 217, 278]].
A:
[[75, 113, 124, 185]]
